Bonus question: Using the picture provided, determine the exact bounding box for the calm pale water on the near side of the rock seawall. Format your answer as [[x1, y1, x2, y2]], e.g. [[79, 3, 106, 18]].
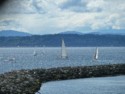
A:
[[36, 76, 125, 94]]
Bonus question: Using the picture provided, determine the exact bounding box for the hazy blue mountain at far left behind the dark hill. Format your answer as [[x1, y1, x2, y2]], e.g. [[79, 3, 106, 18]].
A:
[[0, 30, 31, 37]]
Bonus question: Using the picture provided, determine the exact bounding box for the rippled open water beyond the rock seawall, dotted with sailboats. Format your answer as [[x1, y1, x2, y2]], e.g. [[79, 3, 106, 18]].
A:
[[0, 47, 125, 73]]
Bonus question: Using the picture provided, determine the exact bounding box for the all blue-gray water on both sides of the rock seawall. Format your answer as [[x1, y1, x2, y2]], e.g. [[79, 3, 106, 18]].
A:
[[0, 47, 125, 94]]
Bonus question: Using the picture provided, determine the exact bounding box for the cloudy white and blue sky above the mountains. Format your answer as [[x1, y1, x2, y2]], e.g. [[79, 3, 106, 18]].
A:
[[0, 0, 125, 34]]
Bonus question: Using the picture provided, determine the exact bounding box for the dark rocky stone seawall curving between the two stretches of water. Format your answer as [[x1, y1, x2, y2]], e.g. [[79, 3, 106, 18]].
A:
[[0, 64, 125, 94]]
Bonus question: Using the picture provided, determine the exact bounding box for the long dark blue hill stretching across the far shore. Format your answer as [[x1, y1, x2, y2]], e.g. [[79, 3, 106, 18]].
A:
[[0, 34, 125, 47]]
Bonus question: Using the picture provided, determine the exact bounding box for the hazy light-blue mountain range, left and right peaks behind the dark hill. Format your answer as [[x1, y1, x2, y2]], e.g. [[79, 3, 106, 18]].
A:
[[0, 29, 125, 37]]
